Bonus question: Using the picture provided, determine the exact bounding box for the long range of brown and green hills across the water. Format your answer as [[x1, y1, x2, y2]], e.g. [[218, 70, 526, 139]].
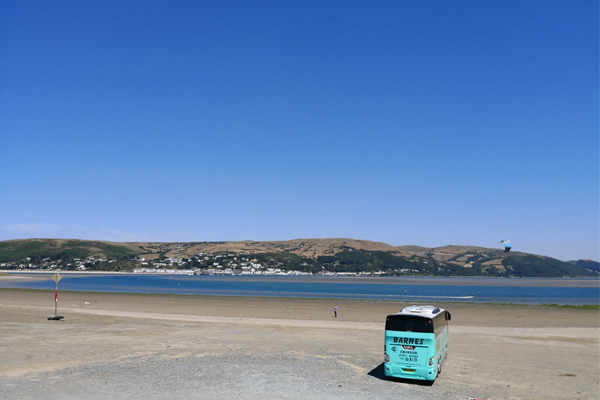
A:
[[0, 238, 598, 277]]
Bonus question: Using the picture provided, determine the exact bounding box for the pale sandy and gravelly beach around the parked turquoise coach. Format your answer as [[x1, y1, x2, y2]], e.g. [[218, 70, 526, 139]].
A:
[[0, 290, 600, 400]]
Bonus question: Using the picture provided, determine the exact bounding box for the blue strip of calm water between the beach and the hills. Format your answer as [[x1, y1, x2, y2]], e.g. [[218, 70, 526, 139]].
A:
[[0, 274, 600, 305]]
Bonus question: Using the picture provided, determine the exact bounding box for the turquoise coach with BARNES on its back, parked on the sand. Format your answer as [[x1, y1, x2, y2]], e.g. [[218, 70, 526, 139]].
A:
[[384, 306, 451, 383]]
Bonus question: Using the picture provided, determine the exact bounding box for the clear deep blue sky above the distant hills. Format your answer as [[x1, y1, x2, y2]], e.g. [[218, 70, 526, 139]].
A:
[[0, 0, 600, 260]]
